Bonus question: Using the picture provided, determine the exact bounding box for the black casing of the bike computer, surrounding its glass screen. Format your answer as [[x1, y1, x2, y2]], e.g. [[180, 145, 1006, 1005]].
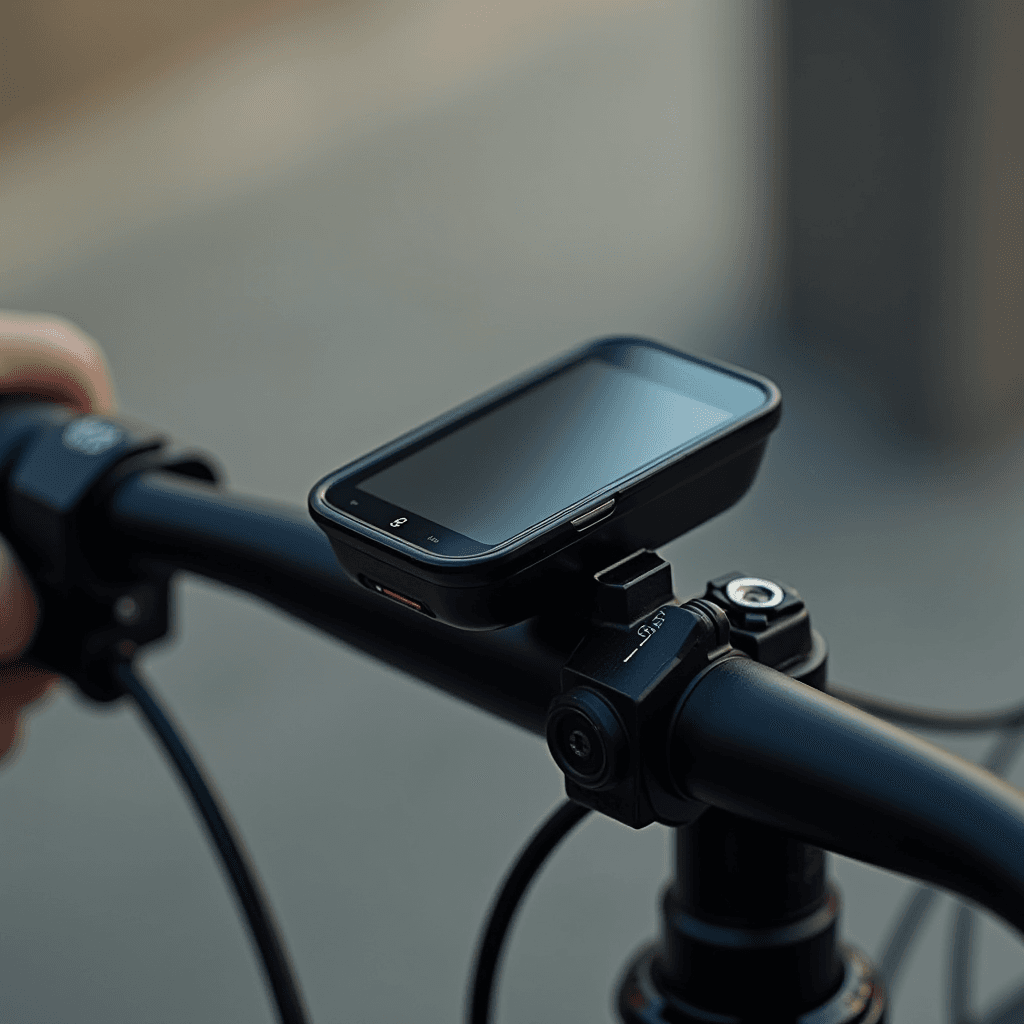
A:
[[309, 338, 780, 630]]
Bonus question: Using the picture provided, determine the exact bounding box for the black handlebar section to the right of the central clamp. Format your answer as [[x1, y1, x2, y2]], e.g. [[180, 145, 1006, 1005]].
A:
[[672, 657, 1024, 932]]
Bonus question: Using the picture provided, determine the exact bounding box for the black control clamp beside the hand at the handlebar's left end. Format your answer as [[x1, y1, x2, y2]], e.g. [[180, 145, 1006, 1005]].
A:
[[0, 395, 217, 701]]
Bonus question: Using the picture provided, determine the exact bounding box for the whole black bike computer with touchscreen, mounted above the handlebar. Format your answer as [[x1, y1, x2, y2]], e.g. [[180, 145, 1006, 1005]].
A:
[[309, 338, 780, 629]]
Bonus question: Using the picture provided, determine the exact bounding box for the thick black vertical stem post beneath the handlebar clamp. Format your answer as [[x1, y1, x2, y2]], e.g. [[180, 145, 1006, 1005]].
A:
[[652, 808, 854, 1021]]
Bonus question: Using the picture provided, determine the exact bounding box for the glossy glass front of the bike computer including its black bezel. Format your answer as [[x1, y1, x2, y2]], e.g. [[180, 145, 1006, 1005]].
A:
[[315, 344, 770, 557]]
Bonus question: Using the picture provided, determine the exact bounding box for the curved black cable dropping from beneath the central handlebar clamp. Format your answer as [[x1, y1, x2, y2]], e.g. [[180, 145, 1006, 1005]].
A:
[[466, 800, 590, 1024]]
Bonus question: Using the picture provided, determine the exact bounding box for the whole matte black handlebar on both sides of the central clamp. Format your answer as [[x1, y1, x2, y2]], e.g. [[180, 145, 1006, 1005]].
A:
[[6, 399, 1024, 931]]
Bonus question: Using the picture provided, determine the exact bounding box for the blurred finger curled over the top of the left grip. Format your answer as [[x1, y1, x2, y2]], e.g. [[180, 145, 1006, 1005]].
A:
[[0, 310, 116, 413]]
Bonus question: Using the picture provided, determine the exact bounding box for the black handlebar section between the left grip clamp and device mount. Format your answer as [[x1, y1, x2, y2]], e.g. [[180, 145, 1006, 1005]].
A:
[[106, 470, 579, 735]]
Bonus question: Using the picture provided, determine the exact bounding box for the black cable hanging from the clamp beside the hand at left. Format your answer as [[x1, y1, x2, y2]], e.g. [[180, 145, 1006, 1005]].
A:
[[114, 664, 308, 1024]]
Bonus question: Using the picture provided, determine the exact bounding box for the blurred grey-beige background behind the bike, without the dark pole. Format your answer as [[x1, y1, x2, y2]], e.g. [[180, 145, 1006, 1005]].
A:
[[0, 0, 1024, 1024]]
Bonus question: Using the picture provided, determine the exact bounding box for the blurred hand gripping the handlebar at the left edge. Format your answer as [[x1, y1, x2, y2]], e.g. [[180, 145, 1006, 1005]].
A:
[[0, 310, 115, 758]]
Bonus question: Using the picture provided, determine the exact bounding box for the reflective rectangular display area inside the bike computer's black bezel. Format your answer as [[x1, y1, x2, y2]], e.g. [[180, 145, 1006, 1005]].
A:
[[358, 359, 730, 546]]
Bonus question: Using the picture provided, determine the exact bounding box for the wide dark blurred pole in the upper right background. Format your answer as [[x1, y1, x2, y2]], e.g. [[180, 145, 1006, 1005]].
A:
[[781, 0, 1024, 440]]
